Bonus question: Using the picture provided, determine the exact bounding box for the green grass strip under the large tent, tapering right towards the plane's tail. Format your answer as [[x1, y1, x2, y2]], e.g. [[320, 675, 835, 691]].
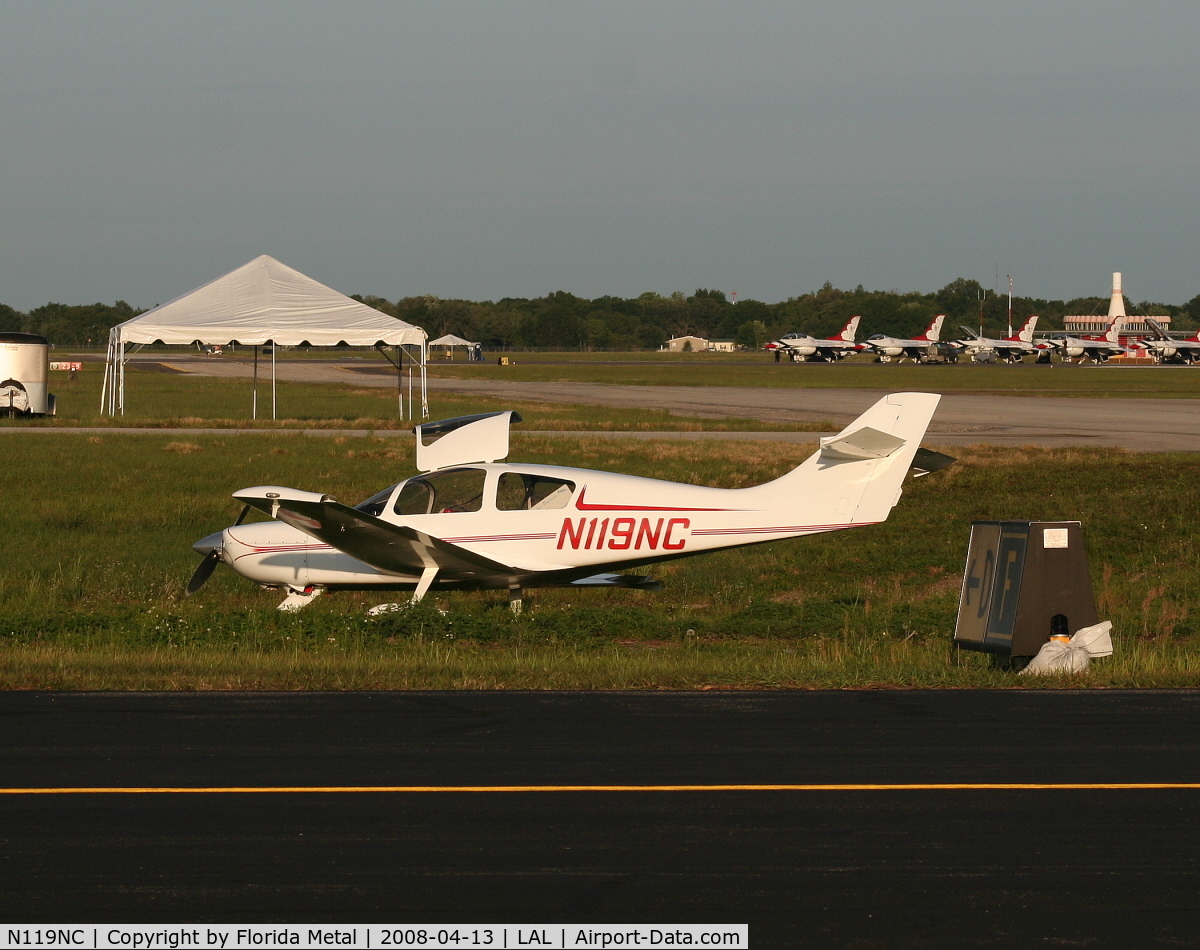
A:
[[0, 363, 838, 432]]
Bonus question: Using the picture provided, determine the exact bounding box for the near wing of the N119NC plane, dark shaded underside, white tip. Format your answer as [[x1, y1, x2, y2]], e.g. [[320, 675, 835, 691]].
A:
[[233, 485, 515, 576]]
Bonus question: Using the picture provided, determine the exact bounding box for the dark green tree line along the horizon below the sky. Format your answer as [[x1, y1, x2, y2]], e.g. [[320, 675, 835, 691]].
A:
[[0, 278, 1200, 350]]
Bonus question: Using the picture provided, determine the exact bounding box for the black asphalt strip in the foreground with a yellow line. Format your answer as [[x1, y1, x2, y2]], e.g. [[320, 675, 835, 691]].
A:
[[0, 691, 1200, 950]]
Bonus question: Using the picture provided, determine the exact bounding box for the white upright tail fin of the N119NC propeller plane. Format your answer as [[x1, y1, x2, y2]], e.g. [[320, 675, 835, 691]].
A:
[[743, 392, 942, 529]]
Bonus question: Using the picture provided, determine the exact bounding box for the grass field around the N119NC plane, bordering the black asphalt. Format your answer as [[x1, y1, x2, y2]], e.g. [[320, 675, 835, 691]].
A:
[[0, 434, 1200, 689]]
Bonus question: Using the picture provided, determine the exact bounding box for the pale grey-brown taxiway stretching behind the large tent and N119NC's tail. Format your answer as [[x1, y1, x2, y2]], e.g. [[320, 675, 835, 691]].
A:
[[131, 359, 1200, 452]]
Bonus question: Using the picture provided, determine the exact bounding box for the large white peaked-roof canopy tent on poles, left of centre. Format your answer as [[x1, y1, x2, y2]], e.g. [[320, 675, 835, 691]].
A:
[[101, 254, 428, 416]]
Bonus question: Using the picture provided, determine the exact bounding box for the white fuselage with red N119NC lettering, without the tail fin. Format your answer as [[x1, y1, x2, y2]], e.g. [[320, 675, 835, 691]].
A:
[[216, 463, 856, 590]]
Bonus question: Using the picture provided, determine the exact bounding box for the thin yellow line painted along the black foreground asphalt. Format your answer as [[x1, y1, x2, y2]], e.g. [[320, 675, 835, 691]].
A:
[[0, 782, 1200, 795]]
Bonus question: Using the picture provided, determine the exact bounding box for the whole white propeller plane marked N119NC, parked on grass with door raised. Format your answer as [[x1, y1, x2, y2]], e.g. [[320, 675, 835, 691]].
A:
[[187, 392, 954, 612]]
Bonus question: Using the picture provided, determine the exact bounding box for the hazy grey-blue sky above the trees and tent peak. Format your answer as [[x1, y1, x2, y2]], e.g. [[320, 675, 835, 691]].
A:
[[0, 0, 1200, 309]]
